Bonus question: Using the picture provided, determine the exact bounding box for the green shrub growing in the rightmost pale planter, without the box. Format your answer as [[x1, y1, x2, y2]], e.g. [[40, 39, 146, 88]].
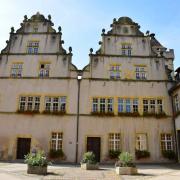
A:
[[115, 152, 135, 167]]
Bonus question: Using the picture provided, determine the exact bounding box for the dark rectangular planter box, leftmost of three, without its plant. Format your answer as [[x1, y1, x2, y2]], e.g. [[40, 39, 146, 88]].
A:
[[27, 165, 47, 175]]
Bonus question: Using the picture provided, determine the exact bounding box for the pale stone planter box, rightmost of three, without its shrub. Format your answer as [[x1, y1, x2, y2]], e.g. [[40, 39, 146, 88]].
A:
[[116, 167, 138, 175]]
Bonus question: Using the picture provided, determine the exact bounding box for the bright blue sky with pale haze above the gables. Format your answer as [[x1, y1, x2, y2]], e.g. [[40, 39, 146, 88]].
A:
[[0, 0, 180, 68]]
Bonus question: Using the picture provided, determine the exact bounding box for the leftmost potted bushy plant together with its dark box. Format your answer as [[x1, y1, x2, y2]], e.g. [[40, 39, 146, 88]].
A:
[[25, 151, 49, 175]]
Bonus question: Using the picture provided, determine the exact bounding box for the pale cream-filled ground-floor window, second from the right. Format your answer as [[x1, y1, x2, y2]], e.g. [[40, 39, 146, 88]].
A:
[[136, 133, 147, 151]]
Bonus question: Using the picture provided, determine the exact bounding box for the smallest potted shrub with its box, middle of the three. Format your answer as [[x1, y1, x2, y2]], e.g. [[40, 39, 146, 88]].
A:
[[81, 152, 99, 170]]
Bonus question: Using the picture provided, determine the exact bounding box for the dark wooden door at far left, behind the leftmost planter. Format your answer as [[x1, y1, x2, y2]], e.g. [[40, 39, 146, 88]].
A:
[[17, 138, 31, 159]]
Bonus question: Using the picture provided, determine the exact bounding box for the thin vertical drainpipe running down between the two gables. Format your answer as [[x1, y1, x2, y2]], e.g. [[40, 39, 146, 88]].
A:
[[75, 72, 82, 164]]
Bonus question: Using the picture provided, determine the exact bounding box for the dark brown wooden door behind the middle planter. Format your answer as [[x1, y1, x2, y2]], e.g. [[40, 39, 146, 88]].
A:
[[87, 137, 101, 162]]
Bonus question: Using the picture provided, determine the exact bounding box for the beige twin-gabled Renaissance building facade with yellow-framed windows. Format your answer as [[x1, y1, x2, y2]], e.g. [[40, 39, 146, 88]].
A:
[[0, 13, 180, 162]]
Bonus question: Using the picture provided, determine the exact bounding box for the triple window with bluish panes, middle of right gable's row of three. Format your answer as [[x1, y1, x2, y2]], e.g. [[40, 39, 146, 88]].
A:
[[118, 98, 139, 113]]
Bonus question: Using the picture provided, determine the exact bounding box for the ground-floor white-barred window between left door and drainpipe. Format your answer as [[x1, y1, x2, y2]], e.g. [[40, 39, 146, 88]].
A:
[[51, 132, 63, 150]]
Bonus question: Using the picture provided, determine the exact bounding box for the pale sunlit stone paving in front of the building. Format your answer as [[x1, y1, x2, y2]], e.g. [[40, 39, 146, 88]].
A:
[[0, 162, 180, 180]]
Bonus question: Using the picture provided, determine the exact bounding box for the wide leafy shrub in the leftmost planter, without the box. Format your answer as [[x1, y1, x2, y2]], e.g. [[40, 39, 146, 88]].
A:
[[25, 151, 49, 167]]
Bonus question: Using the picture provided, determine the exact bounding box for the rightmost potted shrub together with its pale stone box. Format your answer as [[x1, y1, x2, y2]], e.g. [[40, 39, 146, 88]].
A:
[[115, 152, 137, 175]]
